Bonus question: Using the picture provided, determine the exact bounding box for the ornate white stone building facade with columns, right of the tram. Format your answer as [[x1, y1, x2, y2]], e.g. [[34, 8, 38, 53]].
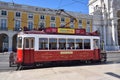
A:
[[88, 0, 120, 50]]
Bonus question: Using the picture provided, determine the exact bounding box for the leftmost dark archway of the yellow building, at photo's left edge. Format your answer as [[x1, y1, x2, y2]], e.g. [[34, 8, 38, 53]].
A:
[[0, 33, 9, 52]]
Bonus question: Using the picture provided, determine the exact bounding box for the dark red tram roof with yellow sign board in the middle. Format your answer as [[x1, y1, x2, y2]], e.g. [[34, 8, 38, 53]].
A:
[[24, 27, 99, 36]]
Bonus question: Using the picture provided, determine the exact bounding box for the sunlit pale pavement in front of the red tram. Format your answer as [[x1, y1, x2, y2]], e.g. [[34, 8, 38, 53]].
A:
[[0, 54, 120, 80]]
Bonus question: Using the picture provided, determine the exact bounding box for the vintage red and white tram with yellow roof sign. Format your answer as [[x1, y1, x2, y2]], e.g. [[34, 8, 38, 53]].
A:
[[16, 28, 106, 67]]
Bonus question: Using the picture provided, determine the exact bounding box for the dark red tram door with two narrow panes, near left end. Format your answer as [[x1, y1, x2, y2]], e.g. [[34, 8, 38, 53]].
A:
[[23, 37, 34, 64]]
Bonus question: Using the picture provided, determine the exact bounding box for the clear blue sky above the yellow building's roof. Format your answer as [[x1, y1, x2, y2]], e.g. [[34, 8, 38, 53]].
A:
[[0, 0, 89, 14]]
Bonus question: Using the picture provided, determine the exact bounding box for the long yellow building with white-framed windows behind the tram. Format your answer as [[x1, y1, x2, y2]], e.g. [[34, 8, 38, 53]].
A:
[[0, 1, 93, 52]]
